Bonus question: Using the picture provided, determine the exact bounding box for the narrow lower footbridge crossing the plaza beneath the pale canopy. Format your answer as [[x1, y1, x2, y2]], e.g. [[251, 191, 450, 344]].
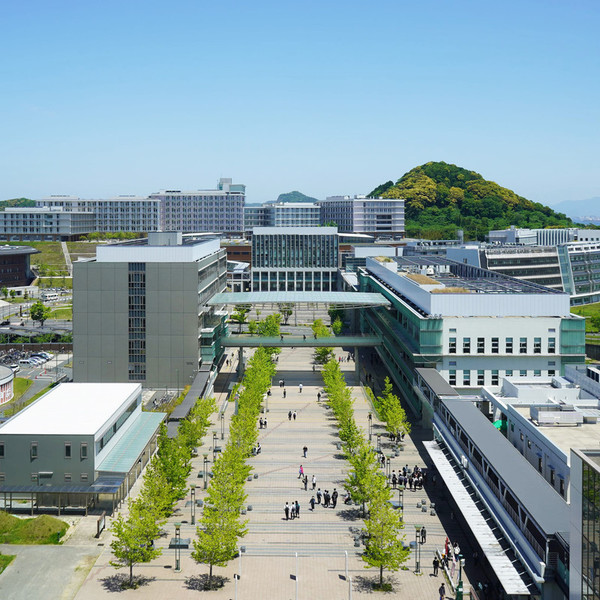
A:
[[219, 333, 382, 348]]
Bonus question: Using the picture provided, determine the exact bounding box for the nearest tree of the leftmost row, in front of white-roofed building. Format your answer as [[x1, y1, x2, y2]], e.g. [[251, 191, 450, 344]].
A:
[[110, 501, 161, 587]]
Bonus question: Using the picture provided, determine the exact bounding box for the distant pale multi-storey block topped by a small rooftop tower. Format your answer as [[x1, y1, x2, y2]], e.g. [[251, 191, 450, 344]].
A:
[[149, 178, 246, 235]]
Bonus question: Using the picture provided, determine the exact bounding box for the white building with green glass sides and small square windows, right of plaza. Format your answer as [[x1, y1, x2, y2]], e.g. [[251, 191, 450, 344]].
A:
[[358, 257, 585, 424]]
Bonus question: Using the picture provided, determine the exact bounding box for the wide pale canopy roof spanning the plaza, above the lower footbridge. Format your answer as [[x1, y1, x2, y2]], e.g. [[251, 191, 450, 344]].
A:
[[207, 292, 390, 310]]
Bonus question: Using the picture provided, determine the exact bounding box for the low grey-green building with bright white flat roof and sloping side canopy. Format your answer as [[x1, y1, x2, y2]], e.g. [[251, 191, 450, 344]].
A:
[[0, 383, 165, 514]]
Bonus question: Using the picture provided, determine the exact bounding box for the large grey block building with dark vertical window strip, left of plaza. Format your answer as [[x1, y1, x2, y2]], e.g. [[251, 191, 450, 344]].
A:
[[73, 232, 226, 389]]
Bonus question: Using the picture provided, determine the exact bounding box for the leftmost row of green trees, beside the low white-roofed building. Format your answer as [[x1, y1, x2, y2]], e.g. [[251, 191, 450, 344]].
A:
[[110, 398, 216, 587]]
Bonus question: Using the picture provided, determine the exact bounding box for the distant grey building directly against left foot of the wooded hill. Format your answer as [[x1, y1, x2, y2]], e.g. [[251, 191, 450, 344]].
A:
[[319, 196, 404, 239]]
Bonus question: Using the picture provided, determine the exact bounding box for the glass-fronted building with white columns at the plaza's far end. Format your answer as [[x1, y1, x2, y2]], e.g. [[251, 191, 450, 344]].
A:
[[252, 227, 338, 292]]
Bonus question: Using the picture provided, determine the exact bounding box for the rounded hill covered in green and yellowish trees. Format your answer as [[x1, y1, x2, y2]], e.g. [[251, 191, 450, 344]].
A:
[[369, 162, 574, 240]]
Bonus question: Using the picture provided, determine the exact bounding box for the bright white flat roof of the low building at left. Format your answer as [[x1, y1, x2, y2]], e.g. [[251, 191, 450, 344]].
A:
[[0, 383, 141, 437]]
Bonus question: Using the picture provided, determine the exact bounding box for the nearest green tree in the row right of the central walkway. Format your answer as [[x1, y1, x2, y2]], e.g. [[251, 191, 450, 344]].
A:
[[362, 495, 410, 589]]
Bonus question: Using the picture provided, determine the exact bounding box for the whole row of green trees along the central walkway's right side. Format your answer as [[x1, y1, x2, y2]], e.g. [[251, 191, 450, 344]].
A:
[[322, 359, 410, 589]]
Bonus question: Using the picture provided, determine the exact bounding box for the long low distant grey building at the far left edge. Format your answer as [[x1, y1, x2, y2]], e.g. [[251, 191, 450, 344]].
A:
[[0, 208, 95, 241]]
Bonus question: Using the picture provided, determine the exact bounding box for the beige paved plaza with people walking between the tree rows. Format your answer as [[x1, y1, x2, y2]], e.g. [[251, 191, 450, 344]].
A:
[[1, 348, 478, 600]]
